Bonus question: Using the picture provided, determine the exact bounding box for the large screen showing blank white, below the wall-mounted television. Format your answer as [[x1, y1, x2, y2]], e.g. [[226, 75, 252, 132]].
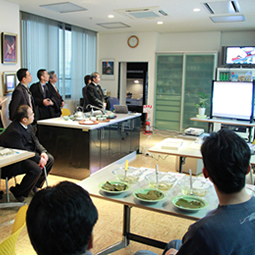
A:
[[210, 81, 255, 122]]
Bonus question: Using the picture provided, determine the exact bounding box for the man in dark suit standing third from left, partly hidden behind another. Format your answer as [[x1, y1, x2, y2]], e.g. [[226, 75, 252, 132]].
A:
[[48, 71, 65, 117]]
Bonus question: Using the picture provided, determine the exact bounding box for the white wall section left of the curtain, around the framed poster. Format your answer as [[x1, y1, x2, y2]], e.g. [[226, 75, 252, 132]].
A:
[[0, 0, 21, 126]]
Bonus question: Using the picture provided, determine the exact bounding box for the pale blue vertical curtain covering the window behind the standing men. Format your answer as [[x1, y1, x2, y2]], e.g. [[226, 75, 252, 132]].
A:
[[21, 12, 97, 110]]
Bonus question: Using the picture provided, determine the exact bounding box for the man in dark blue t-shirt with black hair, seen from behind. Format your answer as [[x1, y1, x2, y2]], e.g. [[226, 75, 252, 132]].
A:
[[136, 129, 255, 255]]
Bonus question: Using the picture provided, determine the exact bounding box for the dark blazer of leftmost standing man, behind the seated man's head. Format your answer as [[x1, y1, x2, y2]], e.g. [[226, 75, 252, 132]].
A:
[[9, 83, 38, 124]]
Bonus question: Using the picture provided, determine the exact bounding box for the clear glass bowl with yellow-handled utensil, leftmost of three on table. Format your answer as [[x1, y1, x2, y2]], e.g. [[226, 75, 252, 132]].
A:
[[112, 167, 142, 184]]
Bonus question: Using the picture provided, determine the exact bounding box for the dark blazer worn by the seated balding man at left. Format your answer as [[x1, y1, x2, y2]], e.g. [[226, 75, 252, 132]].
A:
[[0, 120, 47, 164]]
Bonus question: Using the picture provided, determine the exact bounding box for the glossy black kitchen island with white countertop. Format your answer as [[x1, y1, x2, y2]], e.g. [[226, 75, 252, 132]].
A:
[[38, 113, 141, 174]]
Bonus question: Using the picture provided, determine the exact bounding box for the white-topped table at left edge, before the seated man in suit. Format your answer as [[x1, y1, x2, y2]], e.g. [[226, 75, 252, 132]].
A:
[[0, 147, 35, 208]]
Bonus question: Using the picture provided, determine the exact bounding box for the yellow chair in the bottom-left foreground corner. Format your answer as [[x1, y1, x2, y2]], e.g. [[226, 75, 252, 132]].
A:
[[0, 205, 28, 255]]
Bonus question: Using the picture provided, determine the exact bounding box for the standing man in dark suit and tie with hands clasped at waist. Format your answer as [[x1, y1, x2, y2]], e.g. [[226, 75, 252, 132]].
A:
[[30, 69, 58, 120]]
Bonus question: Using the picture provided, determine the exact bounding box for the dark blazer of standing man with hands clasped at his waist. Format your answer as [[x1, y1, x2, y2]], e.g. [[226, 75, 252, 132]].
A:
[[30, 82, 59, 120]]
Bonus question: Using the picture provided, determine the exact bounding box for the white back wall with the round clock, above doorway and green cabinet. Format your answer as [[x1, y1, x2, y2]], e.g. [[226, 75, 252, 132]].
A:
[[98, 31, 255, 126]]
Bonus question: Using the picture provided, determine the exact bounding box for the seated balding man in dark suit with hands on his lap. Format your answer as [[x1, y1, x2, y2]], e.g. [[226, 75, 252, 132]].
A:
[[0, 105, 54, 202]]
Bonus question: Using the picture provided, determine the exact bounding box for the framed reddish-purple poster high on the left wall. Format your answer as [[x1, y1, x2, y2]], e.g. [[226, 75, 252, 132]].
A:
[[1, 32, 17, 64]]
